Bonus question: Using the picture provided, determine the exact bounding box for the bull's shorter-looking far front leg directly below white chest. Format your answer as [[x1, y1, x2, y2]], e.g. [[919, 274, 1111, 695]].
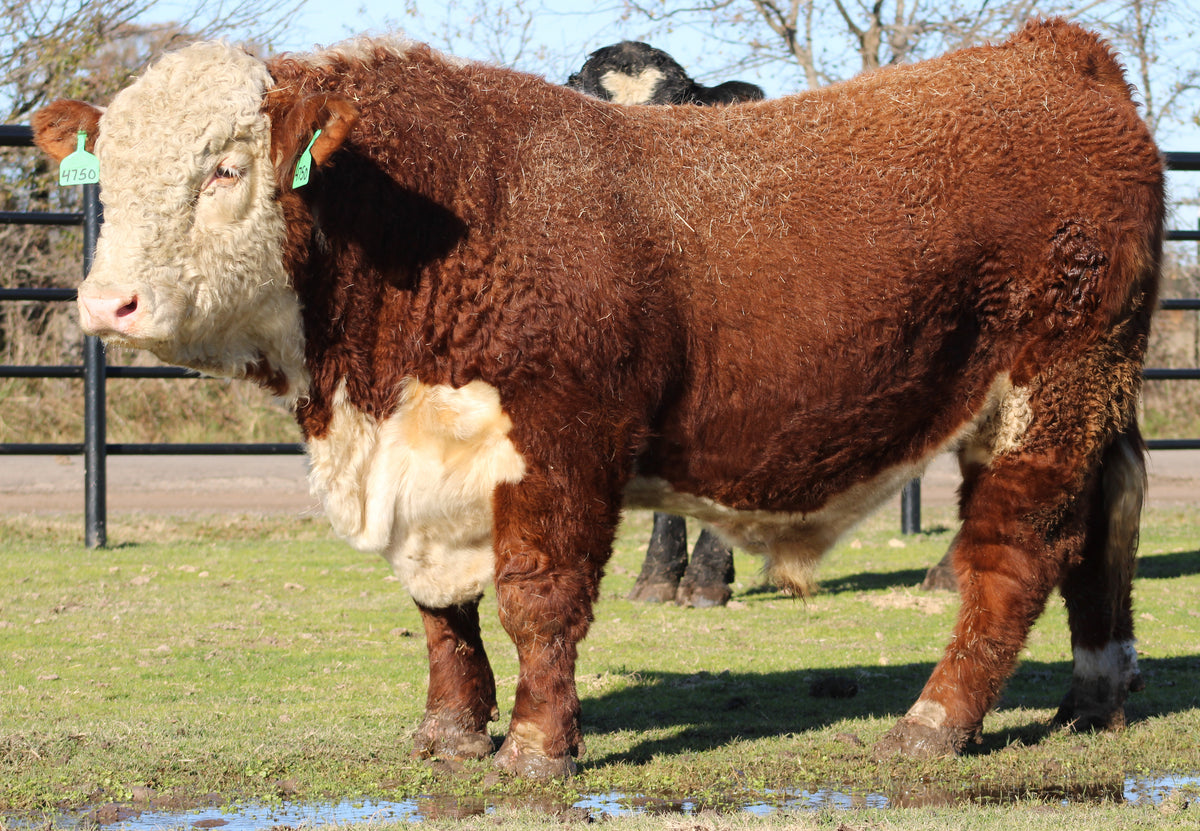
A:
[[413, 599, 499, 759]]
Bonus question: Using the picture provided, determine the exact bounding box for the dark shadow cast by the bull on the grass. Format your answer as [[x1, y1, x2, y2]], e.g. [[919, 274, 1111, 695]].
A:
[[573, 656, 1200, 765]]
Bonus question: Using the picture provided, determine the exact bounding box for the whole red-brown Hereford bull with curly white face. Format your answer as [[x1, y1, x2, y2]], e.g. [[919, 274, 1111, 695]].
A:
[[35, 22, 1164, 777]]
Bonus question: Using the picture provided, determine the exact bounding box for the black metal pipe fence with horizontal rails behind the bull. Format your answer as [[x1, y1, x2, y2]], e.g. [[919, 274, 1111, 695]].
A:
[[0, 125, 1200, 537]]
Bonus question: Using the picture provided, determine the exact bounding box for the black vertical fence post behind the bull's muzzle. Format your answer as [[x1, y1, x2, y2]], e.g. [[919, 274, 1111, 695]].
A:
[[83, 185, 108, 549]]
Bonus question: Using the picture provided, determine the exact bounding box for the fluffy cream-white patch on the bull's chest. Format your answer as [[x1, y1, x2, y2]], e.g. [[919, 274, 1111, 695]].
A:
[[308, 379, 524, 609]]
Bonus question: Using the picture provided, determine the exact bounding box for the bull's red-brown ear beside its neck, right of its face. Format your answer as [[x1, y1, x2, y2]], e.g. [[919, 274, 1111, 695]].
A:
[[268, 92, 359, 187]]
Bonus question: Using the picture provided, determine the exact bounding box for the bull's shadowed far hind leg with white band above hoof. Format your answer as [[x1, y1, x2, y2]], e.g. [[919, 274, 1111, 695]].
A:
[[1055, 428, 1146, 730]]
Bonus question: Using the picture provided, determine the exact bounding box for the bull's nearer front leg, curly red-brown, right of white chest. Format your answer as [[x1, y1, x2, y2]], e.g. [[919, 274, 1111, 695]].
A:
[[496, 480, 617, 779]]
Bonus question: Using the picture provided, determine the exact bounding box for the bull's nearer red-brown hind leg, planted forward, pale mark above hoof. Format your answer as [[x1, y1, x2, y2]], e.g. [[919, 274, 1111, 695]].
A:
[[876, 351, 1136, 757]]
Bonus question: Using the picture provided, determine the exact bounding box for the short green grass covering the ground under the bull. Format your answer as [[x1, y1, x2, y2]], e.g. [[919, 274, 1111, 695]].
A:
[[0, 509, 1200, 827]]
